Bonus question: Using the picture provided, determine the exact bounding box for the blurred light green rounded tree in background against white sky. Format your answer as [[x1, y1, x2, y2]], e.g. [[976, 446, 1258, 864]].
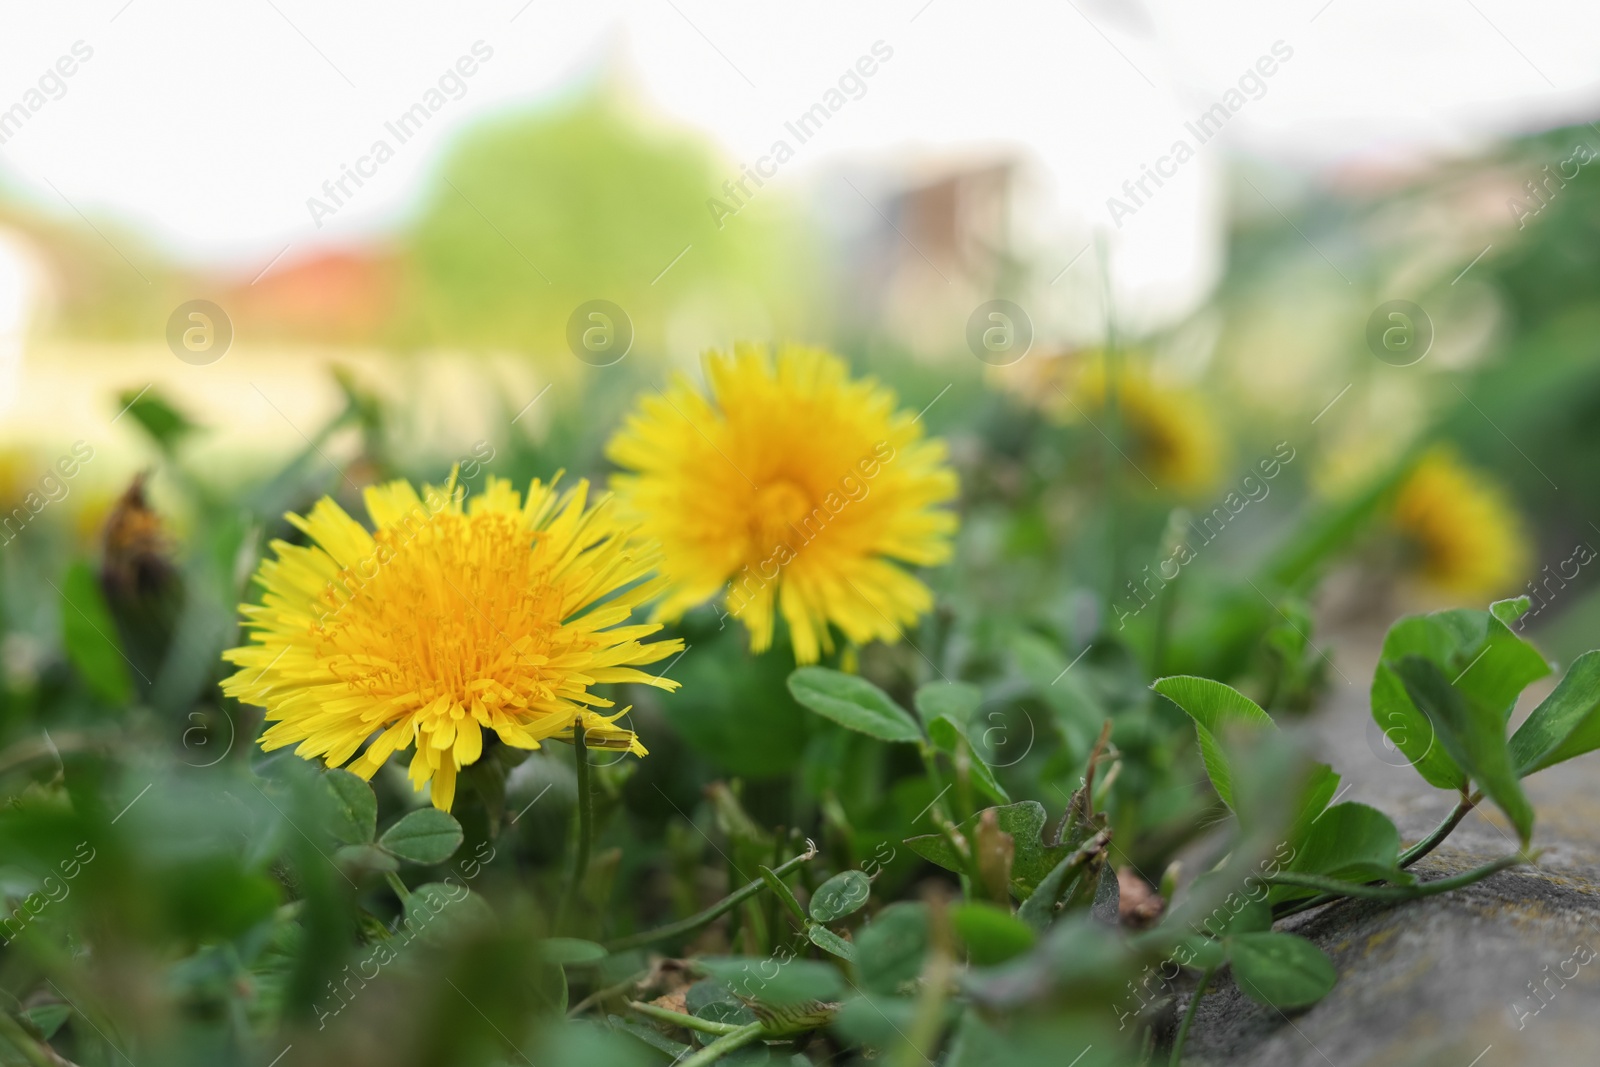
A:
[[406, 90, 814, 357]]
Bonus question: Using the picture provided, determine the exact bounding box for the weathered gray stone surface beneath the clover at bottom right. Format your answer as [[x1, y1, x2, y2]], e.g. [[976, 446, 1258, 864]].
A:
[[1184, 641, 1600, 1067]]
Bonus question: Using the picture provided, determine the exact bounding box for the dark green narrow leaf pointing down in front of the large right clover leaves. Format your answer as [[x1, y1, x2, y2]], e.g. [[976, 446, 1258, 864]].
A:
[[1395, 656, 1533, 846]]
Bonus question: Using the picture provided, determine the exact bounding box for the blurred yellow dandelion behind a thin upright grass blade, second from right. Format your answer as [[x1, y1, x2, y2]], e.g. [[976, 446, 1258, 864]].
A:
[[1066, 358, 1222, 493]]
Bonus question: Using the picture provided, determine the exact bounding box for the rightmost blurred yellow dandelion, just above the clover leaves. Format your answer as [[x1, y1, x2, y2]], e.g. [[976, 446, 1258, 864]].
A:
[[1394, 450, 1528, 601]]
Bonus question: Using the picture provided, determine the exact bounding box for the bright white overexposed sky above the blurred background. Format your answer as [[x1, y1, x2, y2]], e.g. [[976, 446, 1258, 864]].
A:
[[0, 0, 1600, 295]]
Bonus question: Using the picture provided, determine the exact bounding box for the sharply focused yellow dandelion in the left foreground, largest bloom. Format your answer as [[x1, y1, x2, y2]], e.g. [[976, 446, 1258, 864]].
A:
[[222, 475, 683, 811]]
